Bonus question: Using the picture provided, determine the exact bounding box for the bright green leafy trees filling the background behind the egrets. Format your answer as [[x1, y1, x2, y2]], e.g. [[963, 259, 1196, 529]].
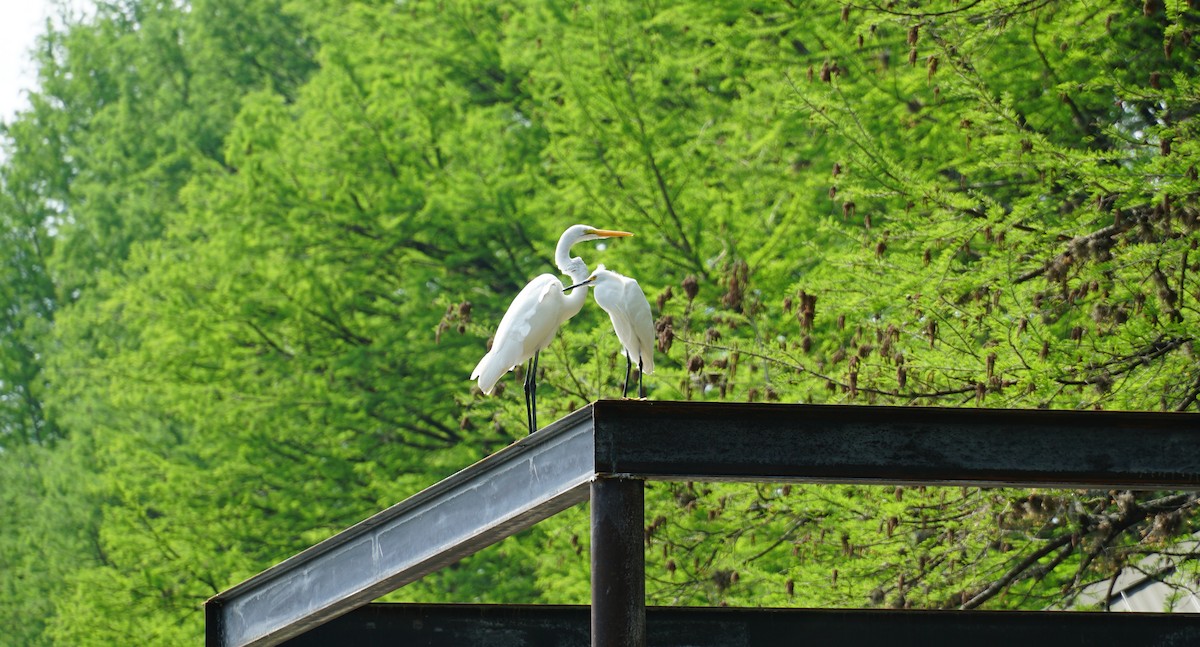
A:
[[0, 0, 1200, 646]]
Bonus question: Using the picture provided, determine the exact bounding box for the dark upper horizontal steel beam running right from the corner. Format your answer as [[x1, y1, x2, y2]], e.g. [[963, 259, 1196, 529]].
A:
[[593, 401, 1200, 489]]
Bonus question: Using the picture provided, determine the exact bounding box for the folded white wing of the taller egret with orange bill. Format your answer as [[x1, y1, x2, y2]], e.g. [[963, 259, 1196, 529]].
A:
[[470, 274, 563, 394]]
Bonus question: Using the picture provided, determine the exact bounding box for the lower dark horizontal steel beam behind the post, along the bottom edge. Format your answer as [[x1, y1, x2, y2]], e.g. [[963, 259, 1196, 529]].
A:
[[287, 604, 1200, 647]]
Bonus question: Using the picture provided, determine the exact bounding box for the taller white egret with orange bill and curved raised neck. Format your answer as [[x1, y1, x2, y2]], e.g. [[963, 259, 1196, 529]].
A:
[[470, 224, 634, 433]]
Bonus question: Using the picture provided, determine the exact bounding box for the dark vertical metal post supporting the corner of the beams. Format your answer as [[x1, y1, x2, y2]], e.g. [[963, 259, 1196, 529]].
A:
[[592, 478, 646, 647]]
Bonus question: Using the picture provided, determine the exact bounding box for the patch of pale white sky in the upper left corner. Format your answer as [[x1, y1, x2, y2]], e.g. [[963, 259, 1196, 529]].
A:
[[0, 0, 52, 121]]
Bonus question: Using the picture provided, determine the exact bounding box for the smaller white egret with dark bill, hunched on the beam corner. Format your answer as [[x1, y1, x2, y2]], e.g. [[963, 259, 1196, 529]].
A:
[[566, 265, 655, 397]]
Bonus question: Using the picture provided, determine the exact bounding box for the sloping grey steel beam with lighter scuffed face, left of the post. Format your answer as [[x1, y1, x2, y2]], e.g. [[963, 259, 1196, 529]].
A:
[[205, 409, 594, 647]]
